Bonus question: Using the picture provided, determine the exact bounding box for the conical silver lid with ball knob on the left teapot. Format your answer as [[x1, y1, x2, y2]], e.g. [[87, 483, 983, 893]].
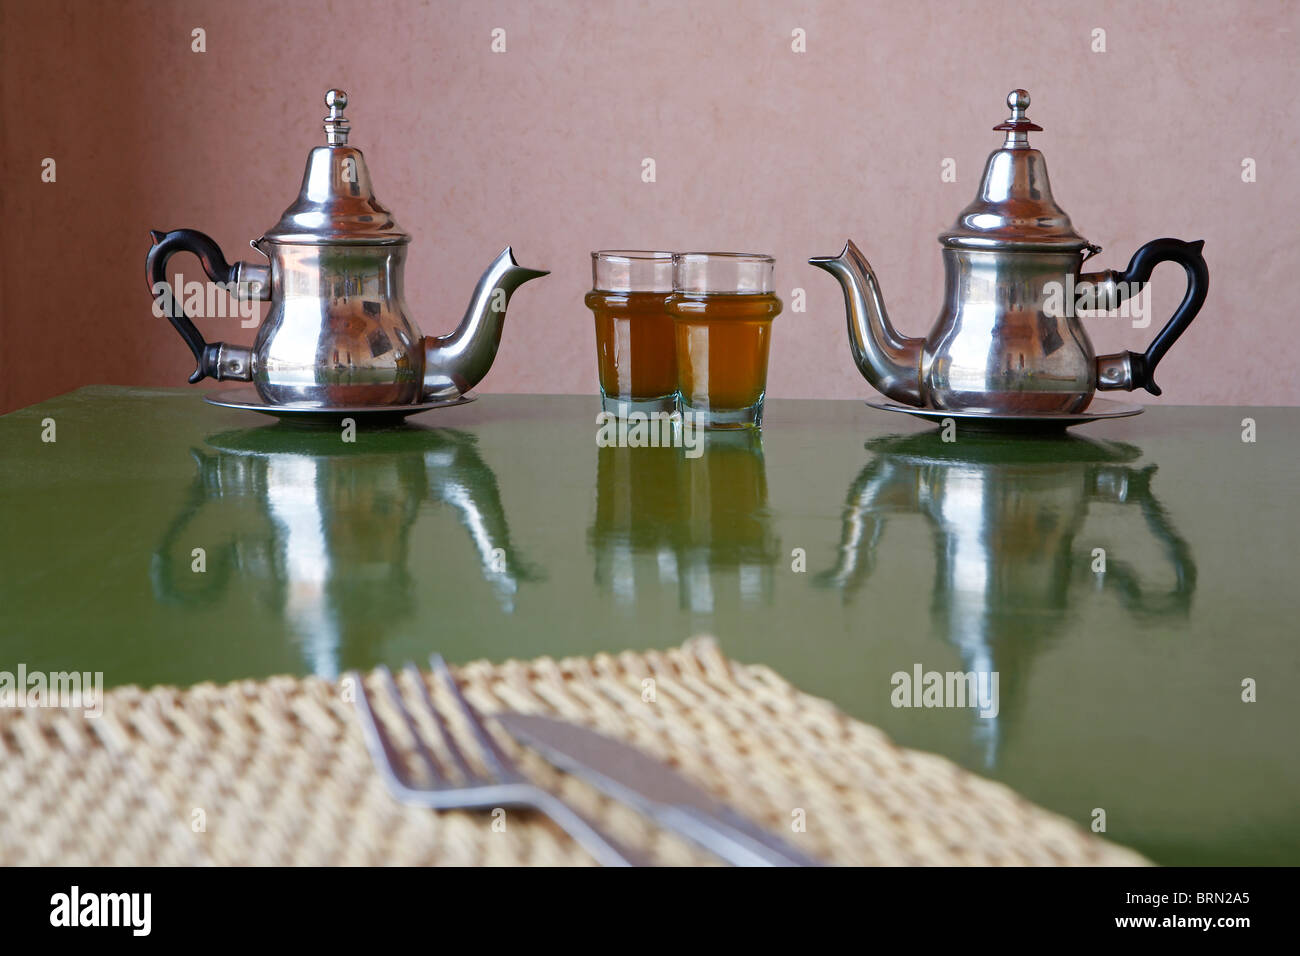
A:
[[263, 90, 411, 245]]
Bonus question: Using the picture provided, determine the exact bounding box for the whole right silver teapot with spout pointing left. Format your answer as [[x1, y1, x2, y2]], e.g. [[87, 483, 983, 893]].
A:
[[809, 90, 1209, 415]]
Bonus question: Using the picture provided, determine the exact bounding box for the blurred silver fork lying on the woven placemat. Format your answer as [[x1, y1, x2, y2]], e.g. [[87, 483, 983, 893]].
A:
[[351, 654, 645, 866]]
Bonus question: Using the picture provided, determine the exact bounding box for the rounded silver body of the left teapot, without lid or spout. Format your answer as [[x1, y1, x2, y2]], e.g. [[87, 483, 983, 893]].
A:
[[252, 242, 424, 407]]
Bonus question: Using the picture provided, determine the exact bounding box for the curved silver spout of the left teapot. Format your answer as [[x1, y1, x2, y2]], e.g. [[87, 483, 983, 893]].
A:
[[423, 246, 550, 402]]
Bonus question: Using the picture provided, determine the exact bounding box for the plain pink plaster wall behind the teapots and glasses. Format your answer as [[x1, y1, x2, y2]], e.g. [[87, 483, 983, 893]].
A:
[[0, 0, 1300, 411]]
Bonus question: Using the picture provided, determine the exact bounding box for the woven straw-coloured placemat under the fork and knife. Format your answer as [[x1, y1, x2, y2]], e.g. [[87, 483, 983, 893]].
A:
[[0, 639, 1145, 865]]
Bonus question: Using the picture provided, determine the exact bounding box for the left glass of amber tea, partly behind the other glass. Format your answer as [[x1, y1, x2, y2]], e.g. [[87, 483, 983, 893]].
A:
[[586, 250, 677, 416]]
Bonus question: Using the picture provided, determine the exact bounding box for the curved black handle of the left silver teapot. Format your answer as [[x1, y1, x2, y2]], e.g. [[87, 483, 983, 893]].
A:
[[144, 229, 263, 385]]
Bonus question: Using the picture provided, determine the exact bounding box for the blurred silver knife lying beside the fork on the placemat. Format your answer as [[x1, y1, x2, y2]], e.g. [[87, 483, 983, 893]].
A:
[[493, 711, 822, 866]]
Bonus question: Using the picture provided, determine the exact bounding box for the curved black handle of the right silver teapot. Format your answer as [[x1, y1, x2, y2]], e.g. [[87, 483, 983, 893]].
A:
[[1097, 239, 1210, 395]]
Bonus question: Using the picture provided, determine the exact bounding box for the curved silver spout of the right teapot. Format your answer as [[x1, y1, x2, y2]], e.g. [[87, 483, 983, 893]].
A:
[[809, 241, 926, 407]]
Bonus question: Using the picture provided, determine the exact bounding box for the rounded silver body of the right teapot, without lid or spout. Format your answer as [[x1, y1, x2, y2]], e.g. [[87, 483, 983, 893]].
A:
[[920, 246, 1097, 415]]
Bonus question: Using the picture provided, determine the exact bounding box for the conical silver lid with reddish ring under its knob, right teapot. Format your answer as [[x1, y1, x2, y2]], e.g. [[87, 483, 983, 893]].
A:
[[939, 90, 1096, 251]]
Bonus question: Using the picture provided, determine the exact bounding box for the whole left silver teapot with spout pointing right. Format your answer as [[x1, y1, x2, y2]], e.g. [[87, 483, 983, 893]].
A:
[[147, 90, 547, 407]]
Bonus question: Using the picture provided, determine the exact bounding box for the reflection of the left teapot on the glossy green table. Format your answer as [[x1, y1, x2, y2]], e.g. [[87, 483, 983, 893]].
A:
[[152, 425, 542, 679]]
